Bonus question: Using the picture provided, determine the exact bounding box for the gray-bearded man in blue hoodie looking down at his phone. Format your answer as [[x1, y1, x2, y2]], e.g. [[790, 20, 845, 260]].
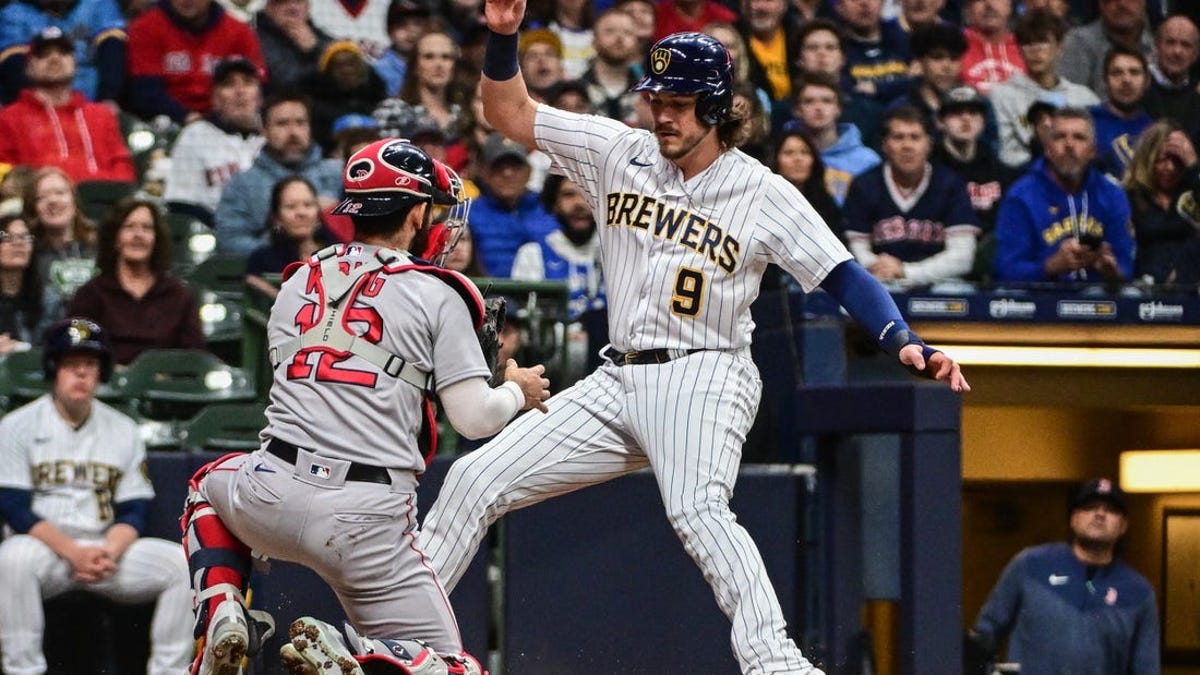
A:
[[992, 108, 1134, 282]]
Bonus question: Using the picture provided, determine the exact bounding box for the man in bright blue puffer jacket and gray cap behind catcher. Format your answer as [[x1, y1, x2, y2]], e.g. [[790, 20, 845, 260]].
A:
[[467, 132, 559, 279]]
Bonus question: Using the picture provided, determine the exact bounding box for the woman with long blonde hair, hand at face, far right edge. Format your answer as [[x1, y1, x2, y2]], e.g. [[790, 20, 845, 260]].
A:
[[1124, 120, 1200, 286]]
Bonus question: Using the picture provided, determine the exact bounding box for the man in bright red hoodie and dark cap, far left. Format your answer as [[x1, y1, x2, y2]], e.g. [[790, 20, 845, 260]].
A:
[[0, 26, 134, 183]]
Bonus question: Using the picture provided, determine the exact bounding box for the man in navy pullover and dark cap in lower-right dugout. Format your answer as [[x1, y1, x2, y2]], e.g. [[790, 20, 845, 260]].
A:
[[971, 478, 1160, 675]]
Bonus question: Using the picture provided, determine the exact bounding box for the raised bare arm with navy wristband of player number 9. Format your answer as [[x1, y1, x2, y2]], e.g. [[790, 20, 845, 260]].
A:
[[481, 0, 538, 148]]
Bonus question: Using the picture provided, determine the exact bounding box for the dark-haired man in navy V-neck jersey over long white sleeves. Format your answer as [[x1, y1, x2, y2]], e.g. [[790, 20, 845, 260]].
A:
[[842, 106, 979, 283]]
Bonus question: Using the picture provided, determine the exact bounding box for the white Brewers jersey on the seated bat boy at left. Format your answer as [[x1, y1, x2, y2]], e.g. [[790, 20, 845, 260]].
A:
[[0, 394, 154, 538]]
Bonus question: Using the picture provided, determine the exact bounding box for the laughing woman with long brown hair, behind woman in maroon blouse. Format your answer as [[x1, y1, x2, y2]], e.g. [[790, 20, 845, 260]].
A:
[[22, 167, 96, 305]]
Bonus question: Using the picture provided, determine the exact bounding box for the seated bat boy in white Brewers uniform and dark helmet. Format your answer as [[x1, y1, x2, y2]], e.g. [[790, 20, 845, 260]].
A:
[[0, 318, 194, 675]]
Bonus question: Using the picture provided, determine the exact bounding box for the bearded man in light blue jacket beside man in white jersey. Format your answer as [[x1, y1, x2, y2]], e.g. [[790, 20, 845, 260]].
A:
[[215, 94, 342, 256]]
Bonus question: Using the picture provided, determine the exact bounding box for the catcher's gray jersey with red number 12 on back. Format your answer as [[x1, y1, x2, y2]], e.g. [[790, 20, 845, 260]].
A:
[[264, 244, 490, 472]]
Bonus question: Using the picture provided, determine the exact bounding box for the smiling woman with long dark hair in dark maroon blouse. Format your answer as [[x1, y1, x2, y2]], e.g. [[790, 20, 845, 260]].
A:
[[68, 197, 205, 365]]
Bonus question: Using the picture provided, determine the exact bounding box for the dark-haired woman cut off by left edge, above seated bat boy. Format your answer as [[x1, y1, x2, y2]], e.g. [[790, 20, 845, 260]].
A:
[[0, 215, 52, 356]]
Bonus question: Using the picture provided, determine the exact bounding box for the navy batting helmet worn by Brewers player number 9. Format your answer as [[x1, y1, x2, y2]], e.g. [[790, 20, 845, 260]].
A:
[[634, 32, 733, 125]]
